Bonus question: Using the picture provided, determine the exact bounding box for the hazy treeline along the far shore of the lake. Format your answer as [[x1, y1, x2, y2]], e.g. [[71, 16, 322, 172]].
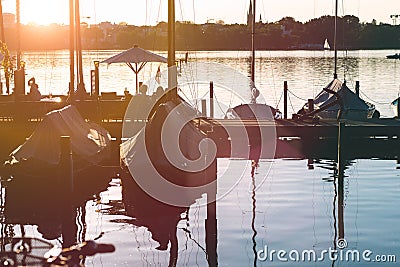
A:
[[5, 16, 400, 51]]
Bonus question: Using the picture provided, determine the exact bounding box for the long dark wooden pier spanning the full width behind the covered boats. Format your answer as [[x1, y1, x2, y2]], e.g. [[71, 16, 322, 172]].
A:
[[0, 96, 400, 163]]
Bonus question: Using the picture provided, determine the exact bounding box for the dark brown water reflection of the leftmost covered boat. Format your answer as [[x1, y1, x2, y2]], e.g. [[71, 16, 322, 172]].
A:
[[1, 165, 110, 251]]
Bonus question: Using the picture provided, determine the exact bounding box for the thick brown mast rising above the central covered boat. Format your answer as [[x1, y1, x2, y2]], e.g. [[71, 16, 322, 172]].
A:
[[168, 0, 178, 93]]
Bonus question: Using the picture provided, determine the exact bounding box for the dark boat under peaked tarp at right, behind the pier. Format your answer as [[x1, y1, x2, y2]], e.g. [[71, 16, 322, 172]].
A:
[[298, 79, 379, 120]]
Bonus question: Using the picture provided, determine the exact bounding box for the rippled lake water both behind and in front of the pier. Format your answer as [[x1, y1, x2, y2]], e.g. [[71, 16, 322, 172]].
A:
[[1, 51, 400, 266]]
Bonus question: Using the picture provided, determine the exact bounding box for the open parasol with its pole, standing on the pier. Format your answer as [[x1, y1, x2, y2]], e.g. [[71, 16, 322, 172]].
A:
[[101, 45, 167, 94]]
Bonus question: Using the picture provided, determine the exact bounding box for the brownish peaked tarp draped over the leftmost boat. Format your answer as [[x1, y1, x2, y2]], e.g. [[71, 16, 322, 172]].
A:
[[10, 105, 111, 164]]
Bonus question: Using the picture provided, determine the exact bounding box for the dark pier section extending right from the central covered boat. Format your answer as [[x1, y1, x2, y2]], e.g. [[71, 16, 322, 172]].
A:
[[196, 118, 400, 158]]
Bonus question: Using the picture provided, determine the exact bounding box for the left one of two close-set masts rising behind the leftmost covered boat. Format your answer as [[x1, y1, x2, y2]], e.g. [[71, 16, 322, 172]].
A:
[[68, 0, 75, 97]]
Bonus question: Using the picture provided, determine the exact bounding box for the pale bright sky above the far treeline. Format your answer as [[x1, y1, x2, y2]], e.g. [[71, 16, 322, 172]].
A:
[[2, 0, 400, 25]]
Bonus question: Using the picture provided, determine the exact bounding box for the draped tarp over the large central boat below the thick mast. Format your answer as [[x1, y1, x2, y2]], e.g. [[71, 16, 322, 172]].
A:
[[120, 100, 211, 206]]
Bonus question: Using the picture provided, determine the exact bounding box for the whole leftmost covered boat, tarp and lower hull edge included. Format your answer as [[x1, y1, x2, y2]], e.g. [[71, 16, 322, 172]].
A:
[[2, 105, 111, 182]]
